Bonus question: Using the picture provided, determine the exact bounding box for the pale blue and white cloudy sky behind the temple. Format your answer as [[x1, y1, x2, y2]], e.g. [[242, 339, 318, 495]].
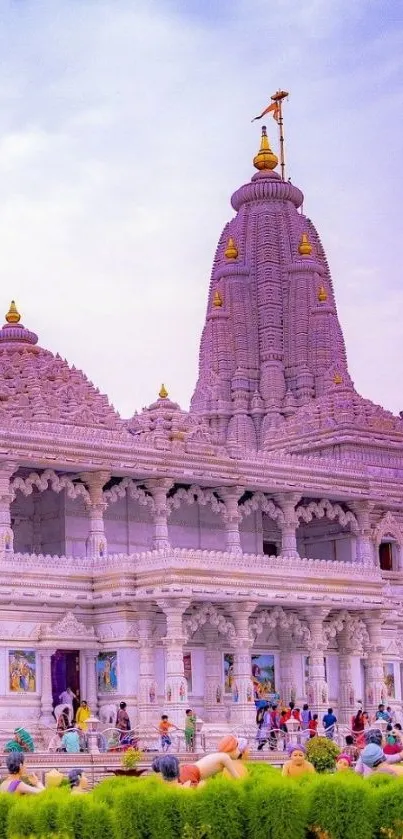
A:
[[0, 0, 403, 417]]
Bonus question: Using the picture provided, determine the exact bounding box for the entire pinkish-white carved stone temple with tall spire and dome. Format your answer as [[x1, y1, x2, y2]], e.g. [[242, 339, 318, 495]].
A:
[[0, 129, 403, 743]]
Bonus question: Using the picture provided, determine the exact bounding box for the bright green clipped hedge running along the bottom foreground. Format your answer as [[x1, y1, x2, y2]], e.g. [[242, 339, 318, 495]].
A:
[[0, 764, 403, 839]]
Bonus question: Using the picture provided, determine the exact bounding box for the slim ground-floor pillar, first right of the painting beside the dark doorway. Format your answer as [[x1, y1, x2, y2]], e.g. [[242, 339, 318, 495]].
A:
[[137, 612, 157, 729]]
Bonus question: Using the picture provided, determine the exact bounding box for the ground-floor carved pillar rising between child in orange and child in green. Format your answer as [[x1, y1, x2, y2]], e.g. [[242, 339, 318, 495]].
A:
[[157, 599, 191, 728]]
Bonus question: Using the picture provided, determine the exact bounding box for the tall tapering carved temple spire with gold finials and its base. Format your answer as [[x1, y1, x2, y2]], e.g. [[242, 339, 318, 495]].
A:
[[191, 128, 403, 451]]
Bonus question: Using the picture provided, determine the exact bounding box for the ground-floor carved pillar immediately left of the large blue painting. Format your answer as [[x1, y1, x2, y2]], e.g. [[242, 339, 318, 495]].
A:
[[229, 602, 256, 730]]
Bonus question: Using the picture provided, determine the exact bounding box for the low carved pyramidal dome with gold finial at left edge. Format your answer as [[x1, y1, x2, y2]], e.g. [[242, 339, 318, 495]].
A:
[[0, 301, 122, 429]]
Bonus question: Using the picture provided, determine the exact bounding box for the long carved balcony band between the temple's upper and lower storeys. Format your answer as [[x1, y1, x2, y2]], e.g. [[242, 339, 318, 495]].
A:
[[0, 548, 386, 609]]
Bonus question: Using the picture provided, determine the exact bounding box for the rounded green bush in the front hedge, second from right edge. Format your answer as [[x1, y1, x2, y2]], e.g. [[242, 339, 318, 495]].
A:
[[304, 773, 374, 839]]
